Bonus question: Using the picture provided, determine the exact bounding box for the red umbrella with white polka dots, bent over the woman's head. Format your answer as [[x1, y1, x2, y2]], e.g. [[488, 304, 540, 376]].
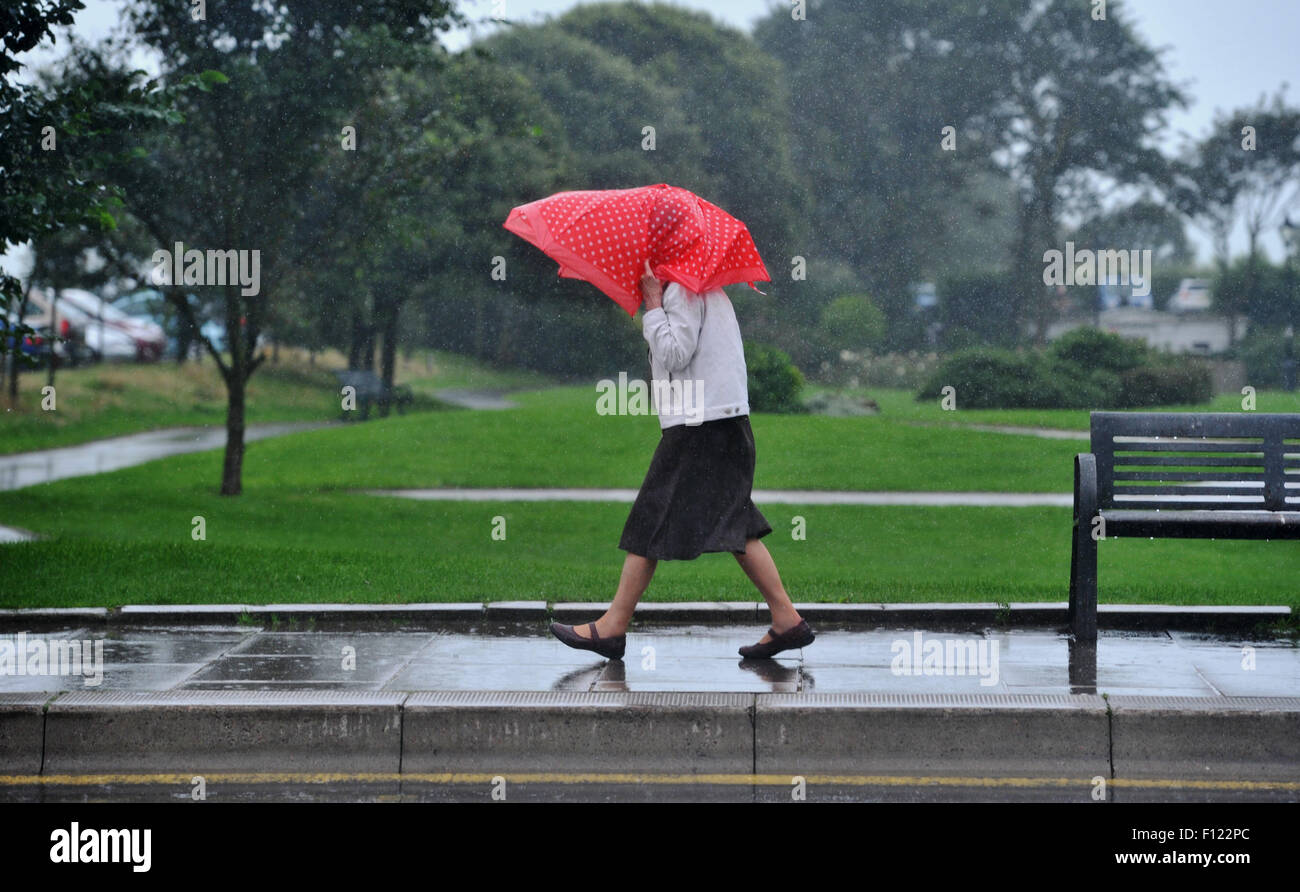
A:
[[504, 183, 771, 315]]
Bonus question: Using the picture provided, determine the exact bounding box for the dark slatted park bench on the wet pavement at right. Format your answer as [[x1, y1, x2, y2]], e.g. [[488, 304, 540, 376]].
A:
[[1069, 412, 1300, 641]]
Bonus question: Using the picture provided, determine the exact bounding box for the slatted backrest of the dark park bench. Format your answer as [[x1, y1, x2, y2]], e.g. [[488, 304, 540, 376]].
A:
[[1091, 412, 1300, 511]]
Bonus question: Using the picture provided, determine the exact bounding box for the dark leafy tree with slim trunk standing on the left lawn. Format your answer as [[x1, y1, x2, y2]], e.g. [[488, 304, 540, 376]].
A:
[[105, 0, 459, 495]]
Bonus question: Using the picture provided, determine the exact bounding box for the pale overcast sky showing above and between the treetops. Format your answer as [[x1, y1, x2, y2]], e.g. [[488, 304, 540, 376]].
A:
[[10, 0, 1300, 267]]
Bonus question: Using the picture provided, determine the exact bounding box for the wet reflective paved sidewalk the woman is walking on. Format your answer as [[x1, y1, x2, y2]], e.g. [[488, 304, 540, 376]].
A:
[[0, 623, 1300, 697]]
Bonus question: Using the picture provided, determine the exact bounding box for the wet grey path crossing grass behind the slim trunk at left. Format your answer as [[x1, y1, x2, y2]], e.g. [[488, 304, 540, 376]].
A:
[[0, 421, 332, 490]]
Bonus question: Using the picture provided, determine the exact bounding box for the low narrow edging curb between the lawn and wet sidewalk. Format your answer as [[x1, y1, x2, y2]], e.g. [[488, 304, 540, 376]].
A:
[[0, 601, 1292, 633]]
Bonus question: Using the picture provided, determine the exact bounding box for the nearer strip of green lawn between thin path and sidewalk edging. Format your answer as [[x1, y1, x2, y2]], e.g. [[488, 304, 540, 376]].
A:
[[0, 472, 1300, 607]]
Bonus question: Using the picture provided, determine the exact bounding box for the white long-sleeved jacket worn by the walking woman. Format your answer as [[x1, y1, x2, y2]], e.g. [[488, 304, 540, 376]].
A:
[[641, 282, 749, 429]]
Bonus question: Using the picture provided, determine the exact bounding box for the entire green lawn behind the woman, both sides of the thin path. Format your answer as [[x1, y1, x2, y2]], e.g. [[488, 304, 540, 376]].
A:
[[0, 386, 1300, 609]]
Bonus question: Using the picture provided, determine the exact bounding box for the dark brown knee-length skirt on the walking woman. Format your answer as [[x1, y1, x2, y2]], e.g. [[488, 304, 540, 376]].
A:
[[619, 415, 772, 560]]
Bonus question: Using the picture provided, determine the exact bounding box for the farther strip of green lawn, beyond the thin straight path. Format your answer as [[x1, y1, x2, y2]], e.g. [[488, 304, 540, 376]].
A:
[[58, 385, 1080, 491]]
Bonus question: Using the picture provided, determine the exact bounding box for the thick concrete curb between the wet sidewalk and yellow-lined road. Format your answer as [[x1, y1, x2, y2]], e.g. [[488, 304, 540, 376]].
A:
[[0, 690, 1300, 800]]
